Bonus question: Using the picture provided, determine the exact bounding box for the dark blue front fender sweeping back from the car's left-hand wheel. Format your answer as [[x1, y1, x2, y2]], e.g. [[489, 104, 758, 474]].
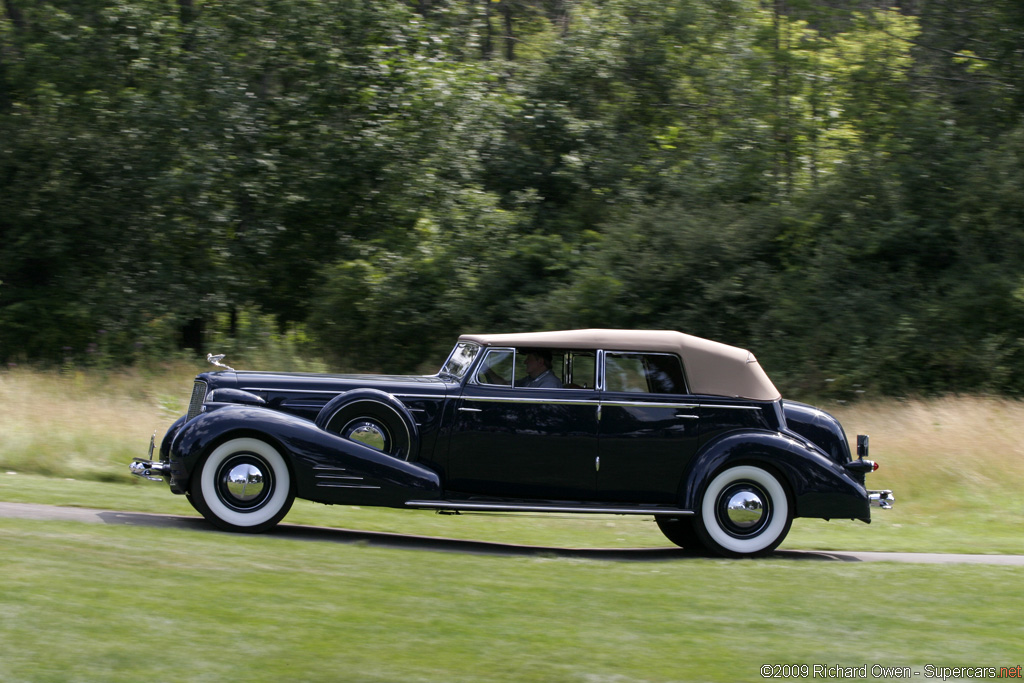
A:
[[170, 405, 441, 506]]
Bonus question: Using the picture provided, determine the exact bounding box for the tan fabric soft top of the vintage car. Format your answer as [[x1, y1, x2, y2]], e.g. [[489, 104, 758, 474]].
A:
[[459, 330, 780, 400]]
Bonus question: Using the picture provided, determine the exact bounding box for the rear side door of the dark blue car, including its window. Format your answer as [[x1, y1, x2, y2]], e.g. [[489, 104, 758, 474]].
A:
[[597, 351, 700, 504]]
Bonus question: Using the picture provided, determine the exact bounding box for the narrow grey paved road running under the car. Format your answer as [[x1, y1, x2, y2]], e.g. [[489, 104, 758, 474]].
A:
[[0, 503, 1024, 566]]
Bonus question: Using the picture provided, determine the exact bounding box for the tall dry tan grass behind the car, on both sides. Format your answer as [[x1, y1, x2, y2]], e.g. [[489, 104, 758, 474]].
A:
[[0, 365, 1024, 499]]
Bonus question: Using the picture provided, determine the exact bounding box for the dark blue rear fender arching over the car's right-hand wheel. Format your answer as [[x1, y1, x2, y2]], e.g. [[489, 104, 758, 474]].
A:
[[681, 431, 870, 521]]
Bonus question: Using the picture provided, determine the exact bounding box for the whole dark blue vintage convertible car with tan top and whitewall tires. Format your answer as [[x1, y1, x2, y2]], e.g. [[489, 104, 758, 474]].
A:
[[131, 330, 892, 556]]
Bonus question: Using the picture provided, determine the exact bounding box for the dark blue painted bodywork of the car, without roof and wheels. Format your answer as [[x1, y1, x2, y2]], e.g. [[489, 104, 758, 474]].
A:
[[161, 372, 869, 519]]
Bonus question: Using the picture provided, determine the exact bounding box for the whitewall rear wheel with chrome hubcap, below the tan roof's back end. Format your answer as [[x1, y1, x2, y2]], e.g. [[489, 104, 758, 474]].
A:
[[695, 465, 793, 557]]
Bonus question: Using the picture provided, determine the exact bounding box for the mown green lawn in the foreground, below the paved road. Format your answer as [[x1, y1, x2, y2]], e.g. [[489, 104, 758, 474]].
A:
[[0, 519, 1024, 682]]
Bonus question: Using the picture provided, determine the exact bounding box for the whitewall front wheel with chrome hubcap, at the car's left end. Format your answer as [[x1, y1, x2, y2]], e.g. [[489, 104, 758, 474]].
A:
[[188, 438, 295, 533]]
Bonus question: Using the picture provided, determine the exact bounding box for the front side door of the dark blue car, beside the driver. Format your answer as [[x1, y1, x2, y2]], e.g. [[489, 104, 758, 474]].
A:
[[446, 348, 599, 501]]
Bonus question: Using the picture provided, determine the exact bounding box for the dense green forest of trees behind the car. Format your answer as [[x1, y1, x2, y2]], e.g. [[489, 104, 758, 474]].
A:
[[0, 0, 1024, 397]]
